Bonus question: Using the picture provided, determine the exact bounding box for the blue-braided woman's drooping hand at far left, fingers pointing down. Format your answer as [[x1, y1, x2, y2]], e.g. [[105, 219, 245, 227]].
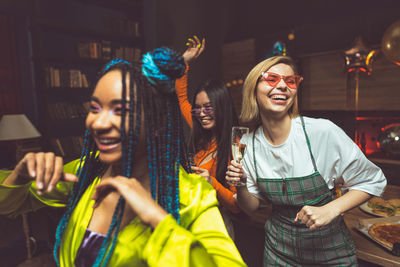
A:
[[4, 152, 78, 195]]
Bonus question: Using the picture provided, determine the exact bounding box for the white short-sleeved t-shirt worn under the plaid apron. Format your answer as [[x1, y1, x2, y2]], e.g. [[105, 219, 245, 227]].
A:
[[241, 117, 386, 198]]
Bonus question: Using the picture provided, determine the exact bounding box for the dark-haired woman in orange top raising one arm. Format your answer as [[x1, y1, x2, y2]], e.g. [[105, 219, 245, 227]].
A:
[[175, 36, 240, 238]]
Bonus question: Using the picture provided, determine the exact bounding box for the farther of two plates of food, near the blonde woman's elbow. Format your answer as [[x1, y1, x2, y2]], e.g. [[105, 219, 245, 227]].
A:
[[359, 197, 400, 217]]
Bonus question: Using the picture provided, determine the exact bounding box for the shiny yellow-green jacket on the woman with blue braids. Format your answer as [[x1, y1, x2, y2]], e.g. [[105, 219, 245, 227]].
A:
[[0, 161, 246, 267]]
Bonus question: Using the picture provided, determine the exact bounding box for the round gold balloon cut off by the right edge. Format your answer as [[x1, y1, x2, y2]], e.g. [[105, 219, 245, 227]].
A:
[[381, 20, 400, 65]]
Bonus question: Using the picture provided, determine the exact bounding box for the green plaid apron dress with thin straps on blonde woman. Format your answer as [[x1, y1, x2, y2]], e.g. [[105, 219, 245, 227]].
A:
[[253, 117, 358, 266]]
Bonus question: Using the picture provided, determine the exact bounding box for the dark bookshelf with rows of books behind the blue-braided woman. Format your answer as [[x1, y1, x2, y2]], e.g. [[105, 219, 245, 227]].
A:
[[30, 0, 144, 161]]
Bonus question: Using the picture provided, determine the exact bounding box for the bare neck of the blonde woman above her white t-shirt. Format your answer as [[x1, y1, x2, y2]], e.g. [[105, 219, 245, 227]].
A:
[[261, 114, 292, 146]]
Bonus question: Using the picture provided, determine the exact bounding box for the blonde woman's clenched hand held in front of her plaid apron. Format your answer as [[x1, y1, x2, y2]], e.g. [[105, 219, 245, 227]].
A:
[[294, 206, 340, 230]]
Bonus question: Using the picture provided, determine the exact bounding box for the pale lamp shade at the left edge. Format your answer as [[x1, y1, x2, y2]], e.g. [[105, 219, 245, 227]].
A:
[[0, 114, 40, 141]]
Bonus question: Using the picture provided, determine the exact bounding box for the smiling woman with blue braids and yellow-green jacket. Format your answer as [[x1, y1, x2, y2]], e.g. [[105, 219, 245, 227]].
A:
[[0, 48, 245, 266]]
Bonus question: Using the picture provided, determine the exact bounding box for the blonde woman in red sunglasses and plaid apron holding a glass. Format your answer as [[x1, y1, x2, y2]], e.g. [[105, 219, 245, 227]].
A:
[[226, 56, 386, 266]]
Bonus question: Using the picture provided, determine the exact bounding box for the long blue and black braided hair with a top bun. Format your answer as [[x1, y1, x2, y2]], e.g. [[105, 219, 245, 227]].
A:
[[53, 47, 190, 266]]
